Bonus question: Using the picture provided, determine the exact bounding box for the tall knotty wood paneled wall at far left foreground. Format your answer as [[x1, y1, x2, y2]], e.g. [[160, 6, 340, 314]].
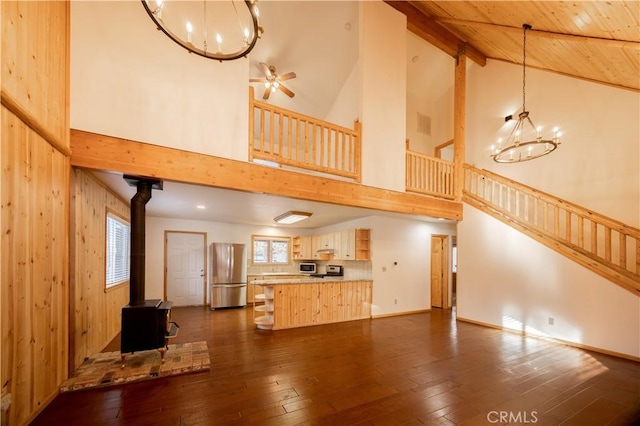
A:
[[0, 1, 70, 425]]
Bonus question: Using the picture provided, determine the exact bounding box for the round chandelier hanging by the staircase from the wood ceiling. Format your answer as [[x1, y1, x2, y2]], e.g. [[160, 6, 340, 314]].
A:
[[491, 24, 560, 163]]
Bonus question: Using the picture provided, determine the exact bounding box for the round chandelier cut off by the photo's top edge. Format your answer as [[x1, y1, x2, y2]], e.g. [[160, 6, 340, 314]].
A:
[[142, 0, 263, 61]]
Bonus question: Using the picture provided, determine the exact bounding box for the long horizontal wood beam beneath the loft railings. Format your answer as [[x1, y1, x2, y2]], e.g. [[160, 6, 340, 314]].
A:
[[71, 130, 462, 220]]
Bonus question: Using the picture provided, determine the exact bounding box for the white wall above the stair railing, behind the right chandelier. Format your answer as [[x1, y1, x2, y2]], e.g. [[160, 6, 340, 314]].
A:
[[466, 60, 640, 227]]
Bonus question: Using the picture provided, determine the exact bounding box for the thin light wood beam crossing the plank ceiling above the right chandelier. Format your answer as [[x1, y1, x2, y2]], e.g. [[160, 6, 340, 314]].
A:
[[434, 18, 640, 50]]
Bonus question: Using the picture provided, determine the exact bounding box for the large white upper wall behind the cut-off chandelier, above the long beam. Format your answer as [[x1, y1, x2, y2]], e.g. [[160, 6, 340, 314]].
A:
[[70, 1, 249, 161]]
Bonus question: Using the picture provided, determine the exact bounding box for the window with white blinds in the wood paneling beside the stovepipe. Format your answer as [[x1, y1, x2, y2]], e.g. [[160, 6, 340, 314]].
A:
[[106, 212, 130, 288]]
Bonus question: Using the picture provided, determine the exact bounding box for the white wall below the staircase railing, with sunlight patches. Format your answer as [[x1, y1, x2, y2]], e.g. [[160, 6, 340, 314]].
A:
[[457, 205, 640, 357]]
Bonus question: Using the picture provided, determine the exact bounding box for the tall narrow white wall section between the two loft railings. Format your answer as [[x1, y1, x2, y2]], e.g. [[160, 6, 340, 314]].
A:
[[360, 1, 407, 191]]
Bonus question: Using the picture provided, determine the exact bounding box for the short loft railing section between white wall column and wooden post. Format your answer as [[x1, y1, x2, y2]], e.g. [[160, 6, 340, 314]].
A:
[[405, 141, 455, 200]]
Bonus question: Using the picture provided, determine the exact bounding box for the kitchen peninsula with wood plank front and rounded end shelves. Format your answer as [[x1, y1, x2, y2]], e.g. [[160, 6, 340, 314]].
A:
[[253, 277, 373, 330]]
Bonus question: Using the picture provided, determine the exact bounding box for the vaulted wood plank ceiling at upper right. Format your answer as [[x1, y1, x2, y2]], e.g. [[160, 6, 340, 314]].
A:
[[387, 0, 640, 91]]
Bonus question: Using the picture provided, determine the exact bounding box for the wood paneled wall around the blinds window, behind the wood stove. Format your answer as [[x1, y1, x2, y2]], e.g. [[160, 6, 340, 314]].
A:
[[70, 169, 129, 371]]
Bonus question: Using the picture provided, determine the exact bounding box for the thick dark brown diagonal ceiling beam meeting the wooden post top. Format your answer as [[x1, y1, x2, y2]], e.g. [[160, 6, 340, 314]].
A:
[[385, 0, 487, 66]]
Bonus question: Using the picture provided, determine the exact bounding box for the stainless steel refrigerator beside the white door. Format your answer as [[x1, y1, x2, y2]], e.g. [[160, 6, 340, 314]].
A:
[[209, 243, 247, 309]]
